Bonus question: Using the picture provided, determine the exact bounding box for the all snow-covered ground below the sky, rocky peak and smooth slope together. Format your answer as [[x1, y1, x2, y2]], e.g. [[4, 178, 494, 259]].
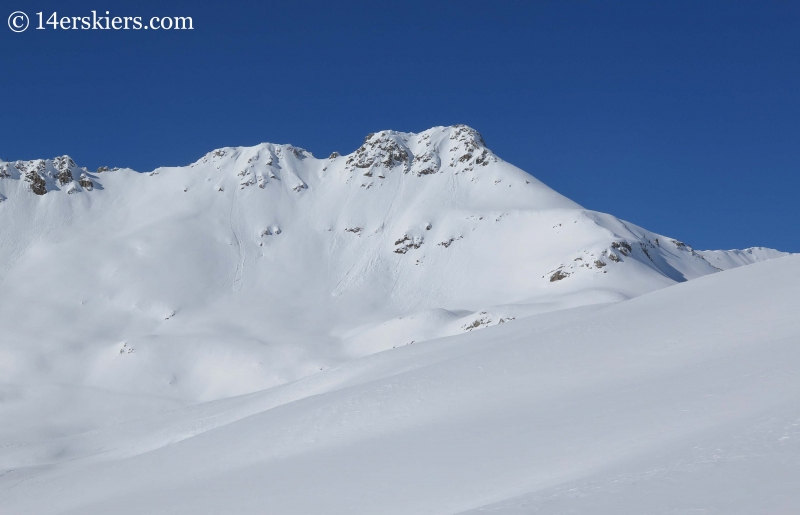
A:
[[0, 126, 800, 514]]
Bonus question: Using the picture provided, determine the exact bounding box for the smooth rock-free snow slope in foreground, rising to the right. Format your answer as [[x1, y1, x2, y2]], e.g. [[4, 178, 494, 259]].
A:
[[0, 256, 800, 515]]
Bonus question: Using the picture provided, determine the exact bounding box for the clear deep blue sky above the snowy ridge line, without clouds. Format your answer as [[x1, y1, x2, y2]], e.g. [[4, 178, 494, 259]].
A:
[[0, 0, 800, 252]]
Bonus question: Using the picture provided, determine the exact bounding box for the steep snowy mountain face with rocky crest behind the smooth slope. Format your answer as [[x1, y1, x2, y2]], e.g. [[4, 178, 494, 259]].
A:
[[0, 126, 792, 433]]
